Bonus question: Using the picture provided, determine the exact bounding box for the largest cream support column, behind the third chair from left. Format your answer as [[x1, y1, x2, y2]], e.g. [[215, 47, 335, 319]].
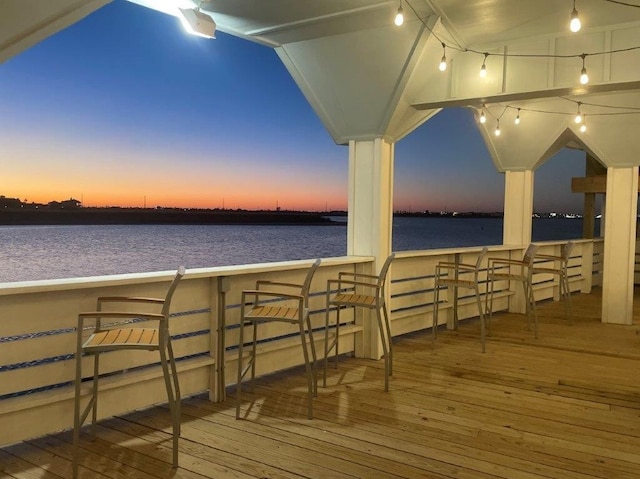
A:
[[347, 138, 394, 359]]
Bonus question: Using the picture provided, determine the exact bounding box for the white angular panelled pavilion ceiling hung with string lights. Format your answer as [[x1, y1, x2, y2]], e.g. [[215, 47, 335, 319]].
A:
[[0, 0, 640, 170]]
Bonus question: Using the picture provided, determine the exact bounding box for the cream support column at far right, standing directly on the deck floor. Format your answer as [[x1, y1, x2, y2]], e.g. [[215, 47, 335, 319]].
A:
[[602, 166, 638, 325]]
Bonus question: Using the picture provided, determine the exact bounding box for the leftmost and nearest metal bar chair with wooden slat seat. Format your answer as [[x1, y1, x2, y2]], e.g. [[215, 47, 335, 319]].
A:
[[73, 266, 185, 479]]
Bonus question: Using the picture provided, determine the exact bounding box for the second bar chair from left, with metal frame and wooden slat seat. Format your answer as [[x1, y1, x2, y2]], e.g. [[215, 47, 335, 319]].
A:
[[236, 259, 321, 419]]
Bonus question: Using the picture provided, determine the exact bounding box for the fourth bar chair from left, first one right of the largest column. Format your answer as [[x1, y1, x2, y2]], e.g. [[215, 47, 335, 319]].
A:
[[432, 246, 489, 353]]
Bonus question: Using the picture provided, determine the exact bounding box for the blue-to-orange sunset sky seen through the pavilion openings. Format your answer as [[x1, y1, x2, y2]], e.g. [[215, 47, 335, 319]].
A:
[[0, 0, 584, 211]]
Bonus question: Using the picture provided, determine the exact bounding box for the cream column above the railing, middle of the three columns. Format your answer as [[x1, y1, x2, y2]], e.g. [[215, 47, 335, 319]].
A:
[[502, 170, 533, 245]]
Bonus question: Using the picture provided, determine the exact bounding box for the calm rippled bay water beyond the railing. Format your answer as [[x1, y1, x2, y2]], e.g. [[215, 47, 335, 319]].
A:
[[0, 218, 582, 282]]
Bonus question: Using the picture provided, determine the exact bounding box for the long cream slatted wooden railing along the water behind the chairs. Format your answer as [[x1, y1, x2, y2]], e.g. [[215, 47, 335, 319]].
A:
[[0, 240, 602, 446]]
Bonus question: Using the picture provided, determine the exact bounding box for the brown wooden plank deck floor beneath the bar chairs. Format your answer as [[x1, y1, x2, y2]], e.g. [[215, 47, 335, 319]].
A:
[[0, 292, 640, 479]]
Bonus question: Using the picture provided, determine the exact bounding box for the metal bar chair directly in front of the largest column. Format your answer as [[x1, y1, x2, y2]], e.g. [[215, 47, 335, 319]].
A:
[[323, 253, 395, 391]]
